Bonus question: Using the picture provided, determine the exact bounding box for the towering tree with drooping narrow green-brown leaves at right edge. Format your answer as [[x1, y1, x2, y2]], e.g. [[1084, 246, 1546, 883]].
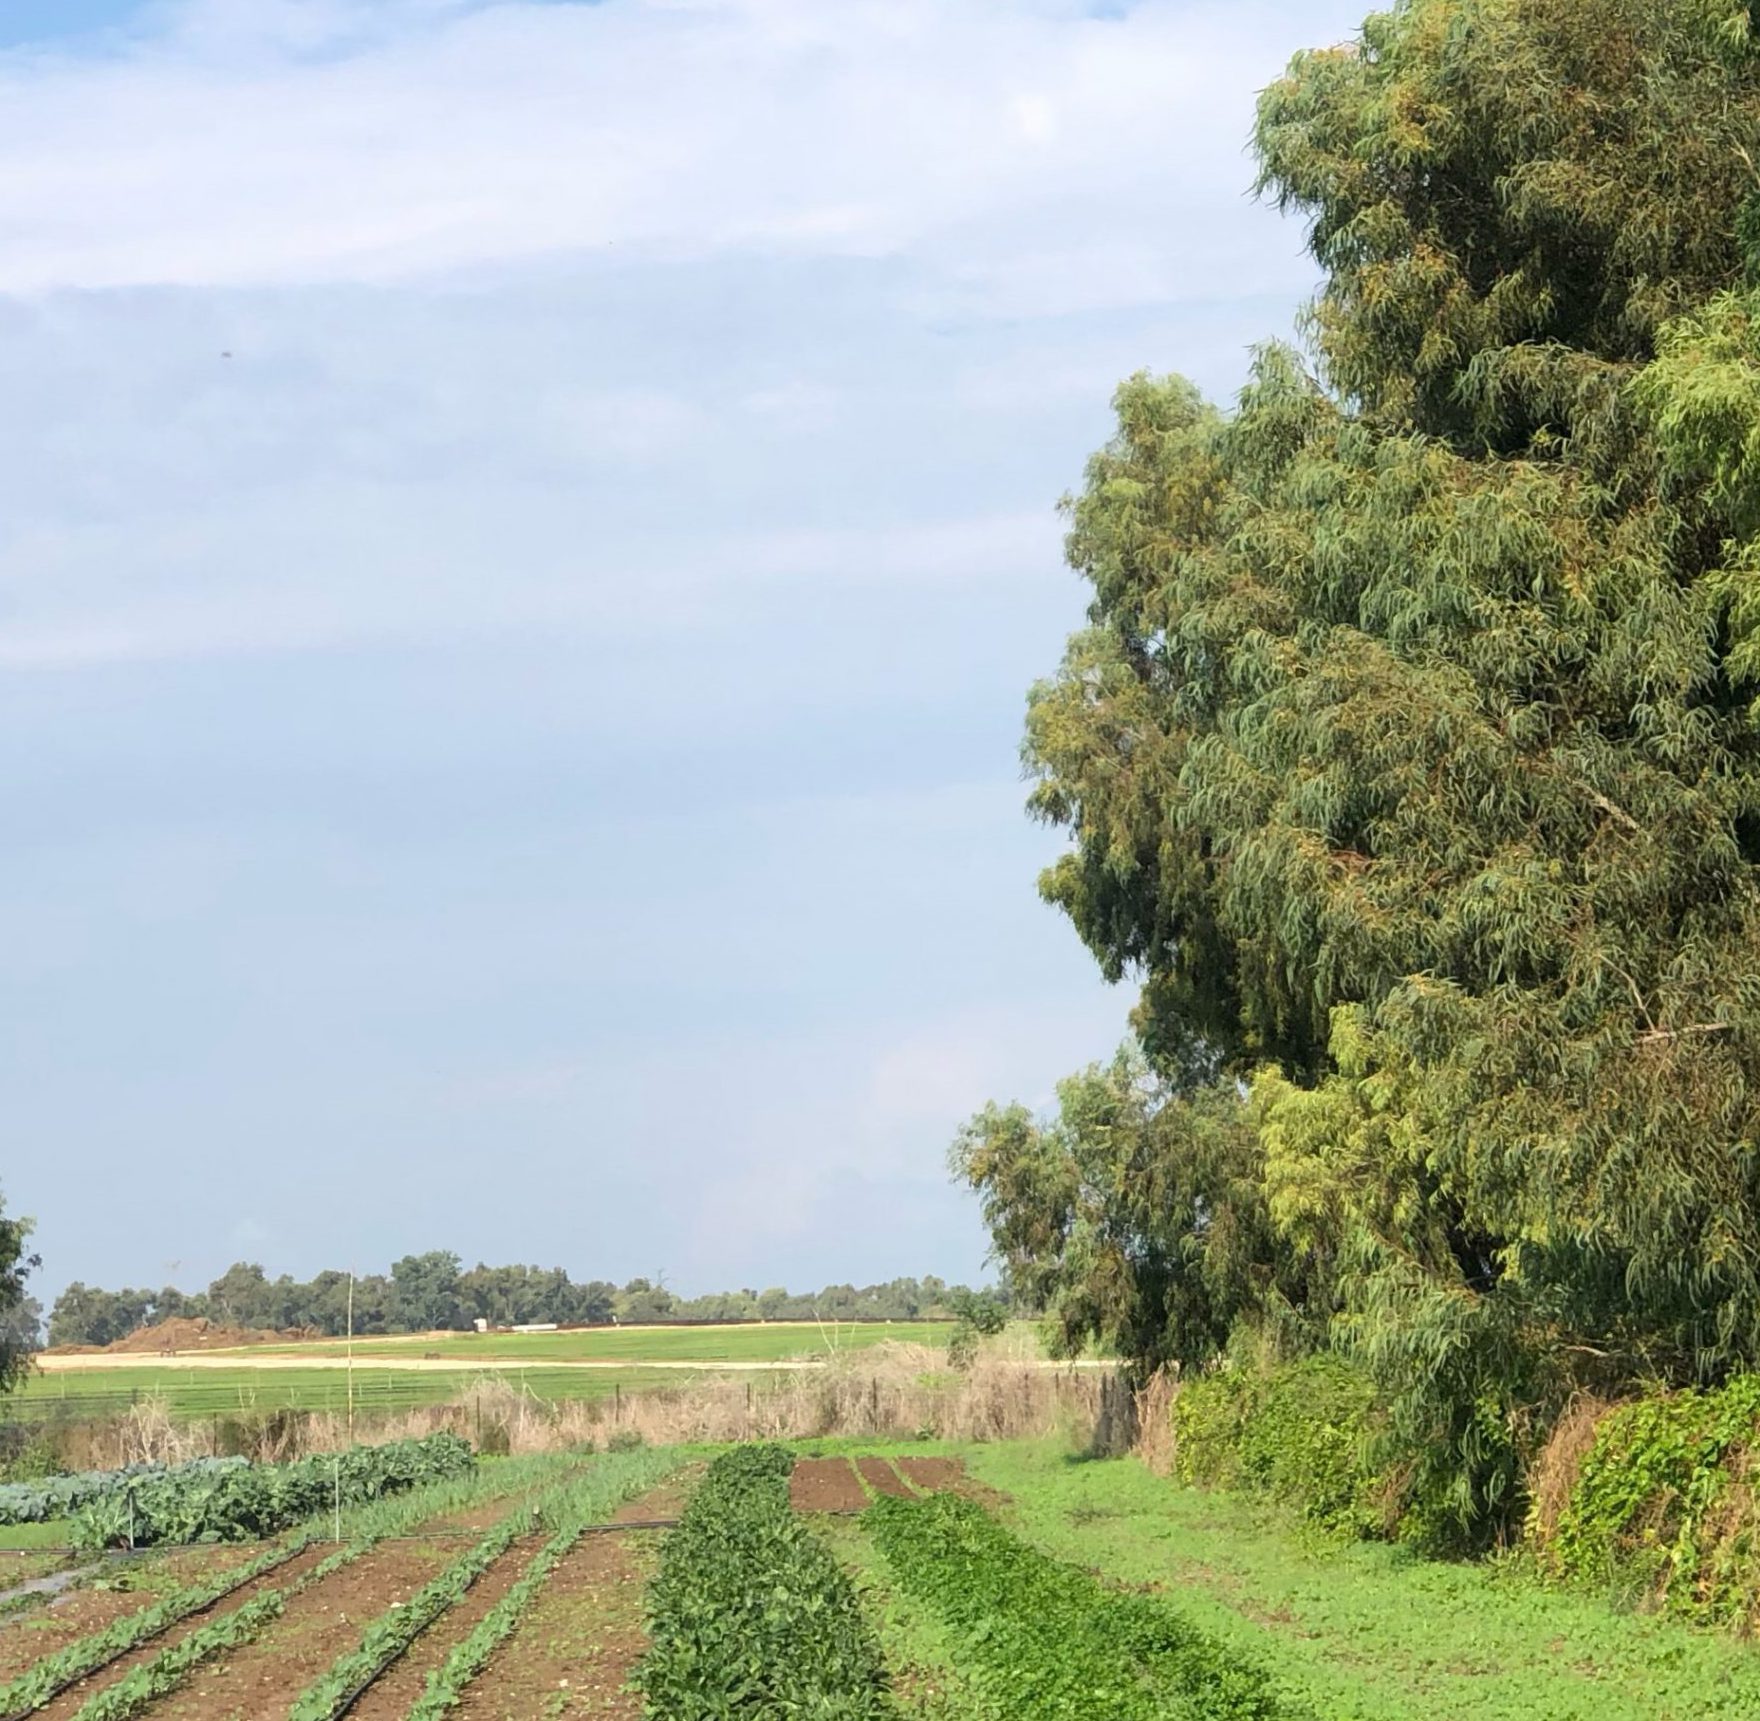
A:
[[961, 0, 1760, 1524]]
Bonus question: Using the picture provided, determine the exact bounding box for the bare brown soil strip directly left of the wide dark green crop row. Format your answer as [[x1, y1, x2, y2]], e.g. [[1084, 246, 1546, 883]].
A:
[[447, 1473, 679, 1721]]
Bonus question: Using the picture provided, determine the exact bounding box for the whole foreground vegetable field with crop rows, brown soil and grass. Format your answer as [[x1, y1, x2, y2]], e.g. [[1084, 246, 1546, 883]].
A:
[[0, 1441, 1760, 1721]]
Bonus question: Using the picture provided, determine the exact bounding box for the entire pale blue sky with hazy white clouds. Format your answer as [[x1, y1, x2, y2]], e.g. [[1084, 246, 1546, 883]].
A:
[[0, 0, 1360, 1297]]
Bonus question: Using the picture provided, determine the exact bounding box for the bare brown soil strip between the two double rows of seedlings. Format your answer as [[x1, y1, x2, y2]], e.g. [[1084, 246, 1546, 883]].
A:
[[132, 1542, 458, 1721]]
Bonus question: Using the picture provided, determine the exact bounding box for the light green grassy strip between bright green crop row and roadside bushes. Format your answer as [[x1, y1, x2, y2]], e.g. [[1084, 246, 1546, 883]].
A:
[[966, 1443, 1760, 1721]]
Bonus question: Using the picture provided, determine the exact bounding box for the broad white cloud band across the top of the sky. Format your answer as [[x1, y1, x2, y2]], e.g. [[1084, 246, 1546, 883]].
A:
[[0, 0, 1348, 300]]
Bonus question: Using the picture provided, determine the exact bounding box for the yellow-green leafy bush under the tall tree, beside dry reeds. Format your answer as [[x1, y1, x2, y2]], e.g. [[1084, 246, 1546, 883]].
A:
[[1172, 1357, 1392, 1536]]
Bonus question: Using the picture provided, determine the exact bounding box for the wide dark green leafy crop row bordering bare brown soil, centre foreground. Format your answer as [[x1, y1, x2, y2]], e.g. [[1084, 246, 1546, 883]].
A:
[[637, 1446, 894, 1721]]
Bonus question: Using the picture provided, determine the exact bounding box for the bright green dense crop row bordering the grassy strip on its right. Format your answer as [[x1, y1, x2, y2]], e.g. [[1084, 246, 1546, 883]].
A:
[[864, 1494, 1308, 1721]]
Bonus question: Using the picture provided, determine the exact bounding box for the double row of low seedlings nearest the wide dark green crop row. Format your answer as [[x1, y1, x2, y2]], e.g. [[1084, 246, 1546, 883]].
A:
[[289, 1452, 679, 1721]]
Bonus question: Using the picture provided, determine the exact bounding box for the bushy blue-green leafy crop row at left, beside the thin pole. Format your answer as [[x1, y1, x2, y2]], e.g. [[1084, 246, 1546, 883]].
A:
[[72, 1432, 475, 1549]]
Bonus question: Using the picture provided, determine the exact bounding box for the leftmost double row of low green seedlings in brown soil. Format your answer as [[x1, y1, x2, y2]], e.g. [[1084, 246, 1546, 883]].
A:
[[0, 1459, 577, 1721]]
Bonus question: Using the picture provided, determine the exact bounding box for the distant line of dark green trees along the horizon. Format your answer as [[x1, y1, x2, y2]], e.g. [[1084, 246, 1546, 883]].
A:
[[49, 1249, 970, 1344]]
